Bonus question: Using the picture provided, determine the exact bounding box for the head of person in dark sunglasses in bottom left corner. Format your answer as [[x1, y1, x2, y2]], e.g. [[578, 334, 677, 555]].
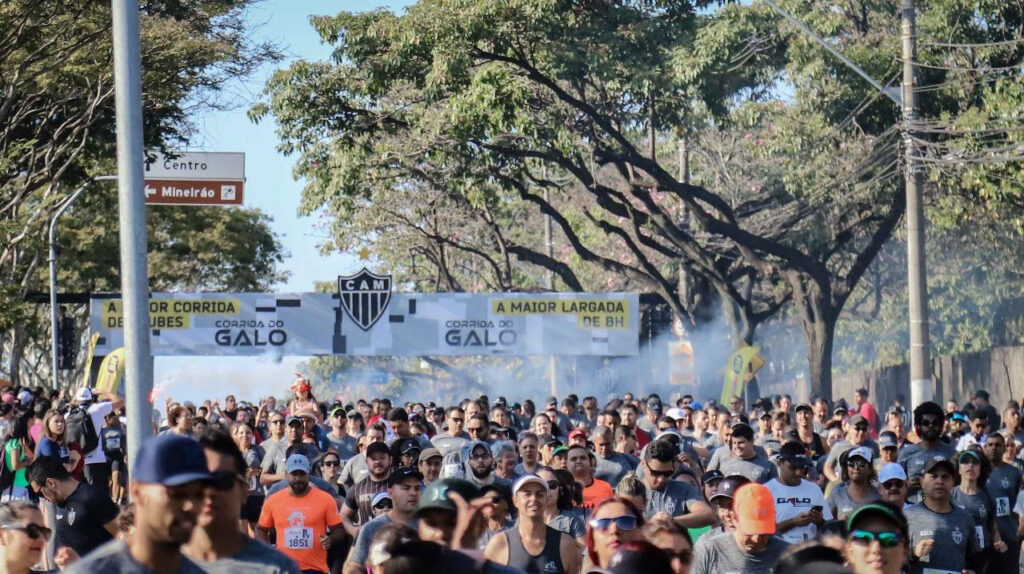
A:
[[0, 500, 56, 574]]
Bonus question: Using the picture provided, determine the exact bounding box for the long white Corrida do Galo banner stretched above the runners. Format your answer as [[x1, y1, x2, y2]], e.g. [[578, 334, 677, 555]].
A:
[[91, 293, 640, 356]]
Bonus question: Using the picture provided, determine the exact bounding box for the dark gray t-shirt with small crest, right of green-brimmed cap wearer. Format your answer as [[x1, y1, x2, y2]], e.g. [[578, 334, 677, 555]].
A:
[[903, 503, 978, 574]]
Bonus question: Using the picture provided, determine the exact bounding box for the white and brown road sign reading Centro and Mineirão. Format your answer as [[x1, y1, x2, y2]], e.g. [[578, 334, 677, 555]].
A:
[[145, 151, 246, 206]]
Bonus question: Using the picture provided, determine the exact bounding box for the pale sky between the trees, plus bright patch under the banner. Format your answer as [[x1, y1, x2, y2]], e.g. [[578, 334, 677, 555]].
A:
[[155, 0, 409, 409]]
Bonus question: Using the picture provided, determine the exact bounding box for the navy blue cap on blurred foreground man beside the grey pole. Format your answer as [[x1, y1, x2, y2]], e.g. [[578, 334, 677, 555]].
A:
[[132, 434, 213, 486]]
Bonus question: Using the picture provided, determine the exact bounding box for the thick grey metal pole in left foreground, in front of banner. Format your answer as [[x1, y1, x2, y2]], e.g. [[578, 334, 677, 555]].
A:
[[112, 0, 153, 460]]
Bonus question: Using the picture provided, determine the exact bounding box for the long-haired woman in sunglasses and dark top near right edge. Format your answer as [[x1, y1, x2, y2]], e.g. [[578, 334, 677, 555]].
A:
[[952, 446, 1007, 572]]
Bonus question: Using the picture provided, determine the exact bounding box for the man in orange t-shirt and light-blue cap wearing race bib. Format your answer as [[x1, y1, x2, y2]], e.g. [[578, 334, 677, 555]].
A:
[[256, 453, 345, 574]]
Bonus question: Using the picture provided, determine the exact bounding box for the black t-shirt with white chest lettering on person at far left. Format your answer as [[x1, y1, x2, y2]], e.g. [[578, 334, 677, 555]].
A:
[[56, 482, 120, 557]]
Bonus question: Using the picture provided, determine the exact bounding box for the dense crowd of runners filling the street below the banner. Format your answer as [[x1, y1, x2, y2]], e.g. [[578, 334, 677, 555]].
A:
[[0, 377, 1024, 574]]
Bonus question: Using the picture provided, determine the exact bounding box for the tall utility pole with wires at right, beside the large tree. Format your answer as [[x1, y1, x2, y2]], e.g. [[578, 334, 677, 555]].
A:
[[900, 0, 934, 408]]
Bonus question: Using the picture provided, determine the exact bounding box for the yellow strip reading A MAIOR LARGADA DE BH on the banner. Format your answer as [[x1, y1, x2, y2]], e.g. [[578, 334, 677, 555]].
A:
[[490, 298, 630, 329]]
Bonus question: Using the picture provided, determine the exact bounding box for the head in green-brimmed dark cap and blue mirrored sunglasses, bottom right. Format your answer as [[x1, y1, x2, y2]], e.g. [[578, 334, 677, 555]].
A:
[[845, 502, 910, 574]]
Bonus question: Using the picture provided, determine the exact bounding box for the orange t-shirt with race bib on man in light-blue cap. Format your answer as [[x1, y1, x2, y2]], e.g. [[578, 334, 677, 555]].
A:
[[259, 485, 341, 572]]
